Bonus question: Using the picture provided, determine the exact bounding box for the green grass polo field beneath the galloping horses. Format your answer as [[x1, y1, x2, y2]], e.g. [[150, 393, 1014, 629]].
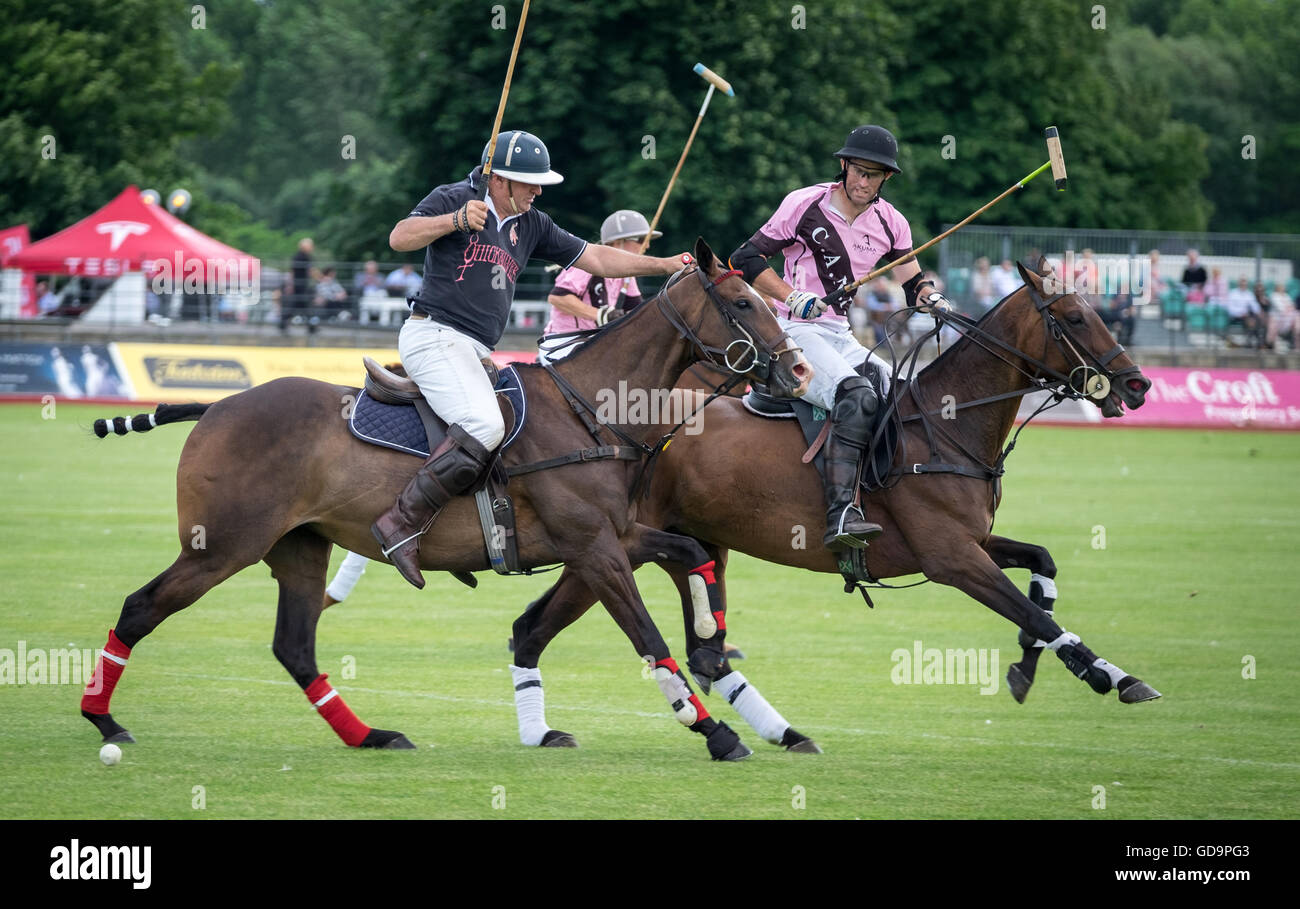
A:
[[0, 404, 1300, 818]]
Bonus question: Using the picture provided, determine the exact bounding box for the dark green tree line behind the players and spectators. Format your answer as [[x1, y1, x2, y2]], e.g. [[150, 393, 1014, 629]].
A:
[[0, 0, 1300, 260]]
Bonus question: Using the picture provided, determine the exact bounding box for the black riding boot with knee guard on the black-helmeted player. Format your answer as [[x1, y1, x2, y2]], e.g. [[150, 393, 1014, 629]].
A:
[[822, 376, 883, 549]]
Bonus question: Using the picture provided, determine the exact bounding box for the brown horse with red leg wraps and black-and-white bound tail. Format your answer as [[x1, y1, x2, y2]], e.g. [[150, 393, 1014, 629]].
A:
[[82, 241, 811, 758]]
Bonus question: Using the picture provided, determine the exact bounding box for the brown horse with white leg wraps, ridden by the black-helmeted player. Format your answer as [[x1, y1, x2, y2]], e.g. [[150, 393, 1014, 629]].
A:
[[514, 260, 1160, 750]]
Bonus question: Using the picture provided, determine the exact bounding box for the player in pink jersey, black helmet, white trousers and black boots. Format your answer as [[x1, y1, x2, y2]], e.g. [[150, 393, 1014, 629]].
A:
[[731, 126, 952, 549]]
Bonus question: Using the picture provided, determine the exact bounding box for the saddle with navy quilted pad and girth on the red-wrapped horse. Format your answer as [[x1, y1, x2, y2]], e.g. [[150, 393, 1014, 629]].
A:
[[347, 356, 528, 574]]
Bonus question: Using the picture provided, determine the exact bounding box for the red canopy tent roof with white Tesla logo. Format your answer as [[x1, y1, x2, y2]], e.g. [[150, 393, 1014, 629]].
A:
[[5, 186, 257, 280]]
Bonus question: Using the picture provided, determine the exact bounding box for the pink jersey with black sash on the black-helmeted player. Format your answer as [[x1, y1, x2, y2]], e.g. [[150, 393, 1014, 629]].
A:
[[749, 183, 911, 324]]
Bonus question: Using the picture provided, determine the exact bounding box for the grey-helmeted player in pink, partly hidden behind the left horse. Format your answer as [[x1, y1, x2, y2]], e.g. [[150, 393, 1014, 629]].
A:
[[537, 208, 663, 363]]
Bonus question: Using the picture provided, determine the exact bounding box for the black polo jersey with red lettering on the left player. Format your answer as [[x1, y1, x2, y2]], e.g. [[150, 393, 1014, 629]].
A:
[[408, 166, 586, 347]]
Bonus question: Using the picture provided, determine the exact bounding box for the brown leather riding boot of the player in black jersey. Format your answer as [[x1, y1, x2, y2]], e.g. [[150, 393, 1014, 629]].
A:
[[371, 424, 491, 589]]
